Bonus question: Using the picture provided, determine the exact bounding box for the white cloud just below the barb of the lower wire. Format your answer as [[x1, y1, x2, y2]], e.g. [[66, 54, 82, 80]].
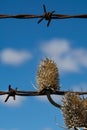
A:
[[0, 95, 26, 107]]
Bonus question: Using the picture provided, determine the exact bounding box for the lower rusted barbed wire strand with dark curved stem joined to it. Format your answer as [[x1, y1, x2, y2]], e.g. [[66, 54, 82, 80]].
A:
[[0, 85, 87, 109]]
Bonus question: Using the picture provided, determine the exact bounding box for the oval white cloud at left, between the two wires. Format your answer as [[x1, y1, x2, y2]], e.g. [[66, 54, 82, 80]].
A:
[[0, 48, 32, 66]]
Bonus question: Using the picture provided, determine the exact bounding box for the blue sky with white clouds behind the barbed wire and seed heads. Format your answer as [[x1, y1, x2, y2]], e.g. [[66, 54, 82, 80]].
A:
[[0, 0, 87, 130]]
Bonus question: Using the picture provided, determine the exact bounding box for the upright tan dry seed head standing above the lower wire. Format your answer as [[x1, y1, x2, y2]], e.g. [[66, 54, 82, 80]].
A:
[[37, 58, 59, 91]]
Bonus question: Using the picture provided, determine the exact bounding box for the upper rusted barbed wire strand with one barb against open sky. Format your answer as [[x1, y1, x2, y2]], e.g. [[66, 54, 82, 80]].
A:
[[0, 5, 87, 27]]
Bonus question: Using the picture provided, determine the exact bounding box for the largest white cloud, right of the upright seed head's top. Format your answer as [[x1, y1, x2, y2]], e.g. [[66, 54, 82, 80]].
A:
[[41, 39, 87, 72]]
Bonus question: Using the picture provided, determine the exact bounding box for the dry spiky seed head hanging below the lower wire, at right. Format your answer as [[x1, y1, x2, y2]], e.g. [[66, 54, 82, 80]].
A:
[[62, 92, 84, 128]]
